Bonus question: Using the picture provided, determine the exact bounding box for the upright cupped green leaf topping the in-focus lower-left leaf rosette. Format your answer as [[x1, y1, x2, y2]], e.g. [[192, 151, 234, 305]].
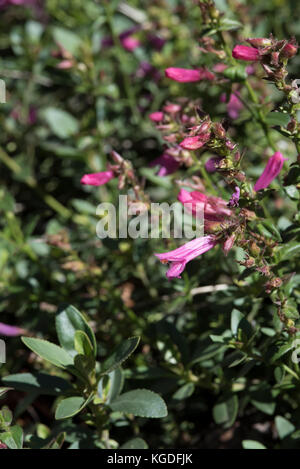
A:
[[55, 305, 97, 356]]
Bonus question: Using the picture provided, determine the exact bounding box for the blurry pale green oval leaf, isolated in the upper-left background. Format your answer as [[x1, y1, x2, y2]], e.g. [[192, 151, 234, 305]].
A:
[[41, 107, 79, 138]]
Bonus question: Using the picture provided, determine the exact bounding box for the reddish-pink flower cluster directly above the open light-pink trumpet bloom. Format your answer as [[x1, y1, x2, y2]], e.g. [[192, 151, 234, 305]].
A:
[[177, 189, 232, 226]]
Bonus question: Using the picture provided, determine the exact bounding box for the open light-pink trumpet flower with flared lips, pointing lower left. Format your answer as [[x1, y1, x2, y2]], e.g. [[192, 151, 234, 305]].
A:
[[155, 235, 217, 278]]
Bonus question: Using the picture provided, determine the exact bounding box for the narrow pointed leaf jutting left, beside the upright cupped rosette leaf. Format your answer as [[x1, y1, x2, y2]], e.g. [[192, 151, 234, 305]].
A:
[[22, 337, 73, 368]]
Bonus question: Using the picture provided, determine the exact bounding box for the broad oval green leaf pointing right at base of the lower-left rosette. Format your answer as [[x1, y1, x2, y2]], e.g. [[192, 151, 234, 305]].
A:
[[110, 389, 168, 418]]
